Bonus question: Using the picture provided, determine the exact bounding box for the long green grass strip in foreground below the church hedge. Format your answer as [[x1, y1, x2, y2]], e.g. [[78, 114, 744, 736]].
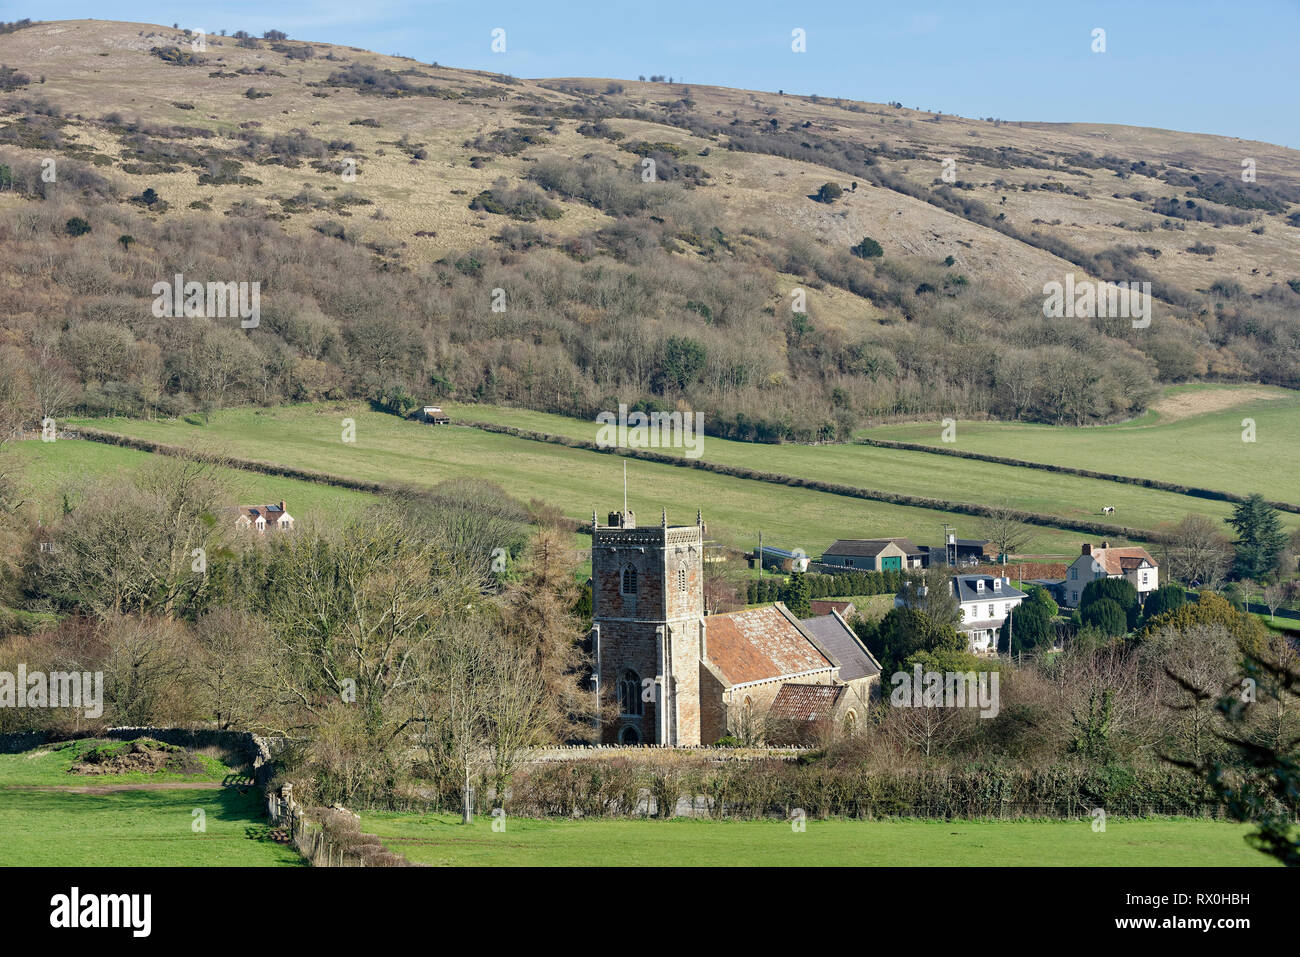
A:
[[361, 813, 1273, 867]]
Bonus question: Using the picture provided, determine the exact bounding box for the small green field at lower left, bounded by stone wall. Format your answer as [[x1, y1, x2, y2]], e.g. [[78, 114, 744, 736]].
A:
[[0, 741, 302, 867]]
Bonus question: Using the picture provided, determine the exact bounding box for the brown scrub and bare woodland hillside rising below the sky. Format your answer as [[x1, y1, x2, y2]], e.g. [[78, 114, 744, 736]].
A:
[[0, 21, 1300, 441]]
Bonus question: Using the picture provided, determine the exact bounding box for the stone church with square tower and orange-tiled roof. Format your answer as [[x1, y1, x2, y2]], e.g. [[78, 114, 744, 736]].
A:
[[592, 511, 880, 746]]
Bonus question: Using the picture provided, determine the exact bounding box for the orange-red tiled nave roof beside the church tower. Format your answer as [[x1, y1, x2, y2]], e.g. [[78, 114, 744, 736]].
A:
[[705, 603, 833, 684]]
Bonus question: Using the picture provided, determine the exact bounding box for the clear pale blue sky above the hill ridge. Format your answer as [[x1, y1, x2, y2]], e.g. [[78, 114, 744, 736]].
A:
[[20, 0, 1300, 148]]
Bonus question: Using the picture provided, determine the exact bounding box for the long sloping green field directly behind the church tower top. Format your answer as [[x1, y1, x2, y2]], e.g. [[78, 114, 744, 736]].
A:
[[65, 406, 1097, 554]]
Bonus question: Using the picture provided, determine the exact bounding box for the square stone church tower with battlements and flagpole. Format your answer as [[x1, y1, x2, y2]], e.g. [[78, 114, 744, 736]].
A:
[[592, 511, 705, 745]]
